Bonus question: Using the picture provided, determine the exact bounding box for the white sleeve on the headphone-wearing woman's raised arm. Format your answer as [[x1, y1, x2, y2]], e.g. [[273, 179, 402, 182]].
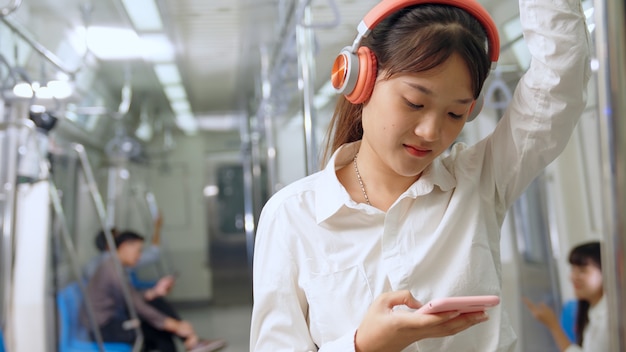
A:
[[481, 0, 591, 208]]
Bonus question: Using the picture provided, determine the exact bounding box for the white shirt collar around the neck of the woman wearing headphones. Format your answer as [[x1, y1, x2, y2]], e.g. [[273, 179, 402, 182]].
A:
[[315, 141, 456, 223]]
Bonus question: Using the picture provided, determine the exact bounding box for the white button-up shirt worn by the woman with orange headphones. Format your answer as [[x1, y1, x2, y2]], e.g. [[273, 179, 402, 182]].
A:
[[250, 0, 590, 352]]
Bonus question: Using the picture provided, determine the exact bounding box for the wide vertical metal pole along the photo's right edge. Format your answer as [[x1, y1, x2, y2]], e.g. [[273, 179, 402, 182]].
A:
[[595, 0, 626, 351]]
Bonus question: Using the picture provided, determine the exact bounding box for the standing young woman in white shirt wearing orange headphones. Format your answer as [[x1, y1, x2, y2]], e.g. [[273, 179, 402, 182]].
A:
[[250, 0, 590, 352]]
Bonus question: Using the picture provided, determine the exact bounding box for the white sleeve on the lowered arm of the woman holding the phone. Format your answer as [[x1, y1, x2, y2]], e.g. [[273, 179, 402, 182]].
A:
[[250, 200, 355, 352]]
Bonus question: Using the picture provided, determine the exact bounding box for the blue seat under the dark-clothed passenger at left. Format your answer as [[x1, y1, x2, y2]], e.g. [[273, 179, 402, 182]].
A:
[[57, 282, 132, 352]]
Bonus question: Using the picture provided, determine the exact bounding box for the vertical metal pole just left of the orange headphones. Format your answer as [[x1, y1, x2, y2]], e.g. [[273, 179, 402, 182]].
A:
[[296, 1, 318, 175]]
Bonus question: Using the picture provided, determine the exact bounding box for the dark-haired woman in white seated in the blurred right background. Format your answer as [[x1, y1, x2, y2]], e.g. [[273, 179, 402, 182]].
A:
[[524, 241, 610, 352]]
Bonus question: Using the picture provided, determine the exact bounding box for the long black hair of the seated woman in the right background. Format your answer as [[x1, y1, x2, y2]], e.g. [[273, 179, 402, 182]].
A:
[[569, 241, 602, 346]]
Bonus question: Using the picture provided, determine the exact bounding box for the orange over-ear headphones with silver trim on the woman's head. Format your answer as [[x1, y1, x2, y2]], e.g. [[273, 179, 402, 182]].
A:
[[331, 0, 500, 121]]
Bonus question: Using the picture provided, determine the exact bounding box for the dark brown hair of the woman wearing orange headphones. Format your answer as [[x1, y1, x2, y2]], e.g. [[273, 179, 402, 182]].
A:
[[322, 4, 491, 164]]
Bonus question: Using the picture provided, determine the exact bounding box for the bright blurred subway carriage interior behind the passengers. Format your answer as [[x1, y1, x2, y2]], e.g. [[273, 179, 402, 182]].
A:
[[0, 0, 624, 352]]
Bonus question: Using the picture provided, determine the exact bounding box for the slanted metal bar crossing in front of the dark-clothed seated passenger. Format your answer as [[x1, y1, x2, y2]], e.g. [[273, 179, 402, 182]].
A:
[[72, 143, 143, 352]]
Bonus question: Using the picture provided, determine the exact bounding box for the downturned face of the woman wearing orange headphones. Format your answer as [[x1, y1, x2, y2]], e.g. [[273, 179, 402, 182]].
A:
[[361, 54, 474, 177]]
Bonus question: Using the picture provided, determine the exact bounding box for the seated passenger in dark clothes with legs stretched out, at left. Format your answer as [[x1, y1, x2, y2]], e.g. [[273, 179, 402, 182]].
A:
[[81, 231, 226, 352]]
